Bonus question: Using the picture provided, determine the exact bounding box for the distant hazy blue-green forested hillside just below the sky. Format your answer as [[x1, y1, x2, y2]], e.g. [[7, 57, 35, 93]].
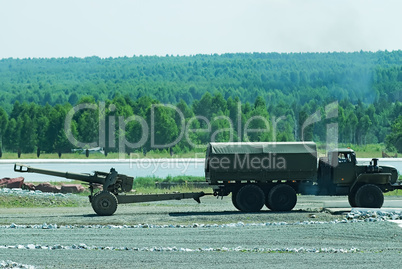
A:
[[0, 51, 402, 113]]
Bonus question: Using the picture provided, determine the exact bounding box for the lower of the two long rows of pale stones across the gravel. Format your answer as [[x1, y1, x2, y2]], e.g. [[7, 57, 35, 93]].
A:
[[0, 244, 360, 253]]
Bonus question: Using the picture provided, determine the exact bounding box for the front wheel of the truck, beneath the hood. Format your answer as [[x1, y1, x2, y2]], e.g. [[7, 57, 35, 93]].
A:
[[355, 184, 384, 208]]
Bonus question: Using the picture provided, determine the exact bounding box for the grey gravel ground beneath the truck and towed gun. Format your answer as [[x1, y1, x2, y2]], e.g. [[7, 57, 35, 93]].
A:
[[0, 196, 402, 268]]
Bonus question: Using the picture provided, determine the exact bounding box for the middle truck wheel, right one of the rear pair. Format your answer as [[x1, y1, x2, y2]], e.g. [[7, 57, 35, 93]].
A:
[[268, 184, 297, 211]]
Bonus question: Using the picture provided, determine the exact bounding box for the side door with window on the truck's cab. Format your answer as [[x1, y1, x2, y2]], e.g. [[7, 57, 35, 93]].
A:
[[333, 152, 356, 184]]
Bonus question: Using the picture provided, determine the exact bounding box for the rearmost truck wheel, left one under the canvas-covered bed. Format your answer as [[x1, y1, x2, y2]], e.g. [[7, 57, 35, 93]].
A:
[[236, 184, 265, 212]]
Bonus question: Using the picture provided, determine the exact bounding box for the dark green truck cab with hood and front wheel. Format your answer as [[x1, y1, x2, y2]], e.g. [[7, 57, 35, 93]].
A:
[[317, 148, 399, 208]]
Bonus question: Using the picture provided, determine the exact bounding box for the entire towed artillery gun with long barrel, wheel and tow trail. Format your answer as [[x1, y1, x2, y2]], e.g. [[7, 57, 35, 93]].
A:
[[14, 163, 205, 216]]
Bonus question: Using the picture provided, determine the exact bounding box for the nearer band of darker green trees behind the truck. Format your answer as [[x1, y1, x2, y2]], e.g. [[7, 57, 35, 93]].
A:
[[0, 92, 402, 153]]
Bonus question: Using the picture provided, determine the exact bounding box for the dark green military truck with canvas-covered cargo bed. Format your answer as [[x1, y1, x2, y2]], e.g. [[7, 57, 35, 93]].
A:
[[205, 142, 402, 212]]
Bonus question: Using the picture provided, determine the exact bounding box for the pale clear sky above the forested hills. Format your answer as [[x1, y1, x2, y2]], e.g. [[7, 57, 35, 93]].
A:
[[0, 0, 402, 59]]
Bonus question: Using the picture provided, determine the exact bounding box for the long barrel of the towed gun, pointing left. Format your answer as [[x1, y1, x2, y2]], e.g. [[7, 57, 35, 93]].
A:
[[14, 163, 106, 184]]
